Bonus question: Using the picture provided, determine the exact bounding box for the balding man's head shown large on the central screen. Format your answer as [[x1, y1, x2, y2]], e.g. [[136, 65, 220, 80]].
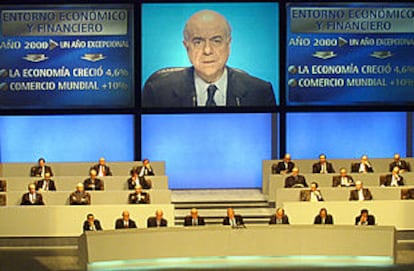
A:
[[184, 11, 231, 83]]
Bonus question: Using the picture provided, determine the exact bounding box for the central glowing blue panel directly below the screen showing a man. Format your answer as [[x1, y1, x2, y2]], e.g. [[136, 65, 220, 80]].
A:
[[142, 114, 271, 189]]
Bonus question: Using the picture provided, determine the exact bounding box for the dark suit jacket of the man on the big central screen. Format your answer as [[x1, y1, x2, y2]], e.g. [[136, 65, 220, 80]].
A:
[[143, 67, 276, 107]]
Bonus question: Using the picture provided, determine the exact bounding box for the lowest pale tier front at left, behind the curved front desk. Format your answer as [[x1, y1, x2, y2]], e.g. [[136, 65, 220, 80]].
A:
[[0, 204, 174, 237]]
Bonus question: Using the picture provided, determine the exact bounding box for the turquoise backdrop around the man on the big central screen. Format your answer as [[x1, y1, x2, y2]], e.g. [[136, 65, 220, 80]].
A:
[[142, 3, 279, 103]]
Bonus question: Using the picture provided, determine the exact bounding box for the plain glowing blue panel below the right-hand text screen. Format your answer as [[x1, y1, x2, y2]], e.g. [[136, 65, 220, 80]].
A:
[[286, 112, 407, 159]]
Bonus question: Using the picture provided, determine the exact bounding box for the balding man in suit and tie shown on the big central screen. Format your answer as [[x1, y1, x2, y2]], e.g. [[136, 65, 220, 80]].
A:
[[143, 10, 276, 107]]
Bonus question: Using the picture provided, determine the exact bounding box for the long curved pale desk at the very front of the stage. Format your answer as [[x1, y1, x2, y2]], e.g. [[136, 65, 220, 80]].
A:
[[79, 225, 396, 270]]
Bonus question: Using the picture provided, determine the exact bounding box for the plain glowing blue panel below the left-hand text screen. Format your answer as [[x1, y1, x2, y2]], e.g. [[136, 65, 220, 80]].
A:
[[0, 115, 134, 163]]
